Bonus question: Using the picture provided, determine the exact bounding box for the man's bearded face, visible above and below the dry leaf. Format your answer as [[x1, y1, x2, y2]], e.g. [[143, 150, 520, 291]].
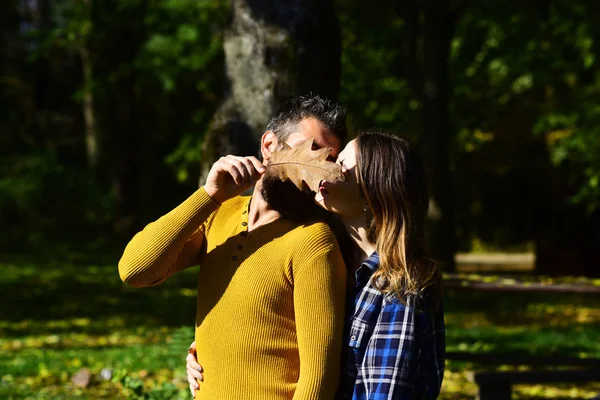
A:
[[261, 118, 341, 220]]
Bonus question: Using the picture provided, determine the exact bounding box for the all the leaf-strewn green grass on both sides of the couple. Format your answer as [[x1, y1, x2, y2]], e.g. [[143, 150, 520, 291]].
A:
[[0, 259, 600, 400]]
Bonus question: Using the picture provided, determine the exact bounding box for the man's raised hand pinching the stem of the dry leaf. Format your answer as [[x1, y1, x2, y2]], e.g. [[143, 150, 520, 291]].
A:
[[204, 155, 266, 204]]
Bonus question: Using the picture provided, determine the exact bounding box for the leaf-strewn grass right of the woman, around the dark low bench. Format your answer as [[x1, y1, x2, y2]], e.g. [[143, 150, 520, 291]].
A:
[[442, 288, 600, 399]]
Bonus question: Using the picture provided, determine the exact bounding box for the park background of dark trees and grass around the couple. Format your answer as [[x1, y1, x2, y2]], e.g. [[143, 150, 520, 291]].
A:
[[0, 0, 600, 399]]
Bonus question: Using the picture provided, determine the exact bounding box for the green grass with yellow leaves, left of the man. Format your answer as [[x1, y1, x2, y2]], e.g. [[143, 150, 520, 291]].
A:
[[0, 261, 197, 399]]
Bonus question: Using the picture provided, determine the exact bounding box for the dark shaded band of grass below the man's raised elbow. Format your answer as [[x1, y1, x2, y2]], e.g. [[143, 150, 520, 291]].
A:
[[0, 260, 198, 336]]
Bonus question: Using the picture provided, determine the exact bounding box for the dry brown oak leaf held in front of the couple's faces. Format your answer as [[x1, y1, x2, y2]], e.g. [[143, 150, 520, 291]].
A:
[[267, 139, 344, 192]]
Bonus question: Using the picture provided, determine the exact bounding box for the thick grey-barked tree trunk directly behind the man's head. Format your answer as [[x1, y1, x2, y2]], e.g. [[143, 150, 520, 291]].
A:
[[200, 0, 341, 183]]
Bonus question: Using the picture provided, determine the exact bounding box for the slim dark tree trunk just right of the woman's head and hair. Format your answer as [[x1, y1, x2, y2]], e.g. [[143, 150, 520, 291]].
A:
[[397, 0, 457, 272]]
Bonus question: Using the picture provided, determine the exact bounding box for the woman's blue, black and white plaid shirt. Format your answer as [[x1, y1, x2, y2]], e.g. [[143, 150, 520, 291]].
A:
[[340, 253, 445, 400]]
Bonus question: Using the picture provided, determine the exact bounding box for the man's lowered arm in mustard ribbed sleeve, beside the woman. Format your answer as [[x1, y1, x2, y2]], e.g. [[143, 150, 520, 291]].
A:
[[294, 230, 346, 400]]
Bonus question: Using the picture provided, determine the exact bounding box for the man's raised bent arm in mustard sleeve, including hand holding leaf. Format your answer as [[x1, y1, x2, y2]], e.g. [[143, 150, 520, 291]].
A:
[[119, 156, 265, 287]]
